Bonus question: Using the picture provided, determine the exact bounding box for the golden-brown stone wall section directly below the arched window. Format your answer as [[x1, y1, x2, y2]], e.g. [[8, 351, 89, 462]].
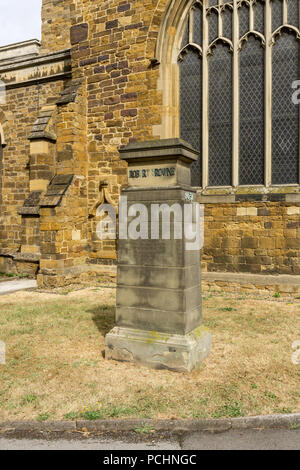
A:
[[202, 202, 300, 275]]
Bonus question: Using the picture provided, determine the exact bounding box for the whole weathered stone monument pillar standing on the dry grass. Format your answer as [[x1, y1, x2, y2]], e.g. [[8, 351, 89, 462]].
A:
[[106, 140, 207, 371]]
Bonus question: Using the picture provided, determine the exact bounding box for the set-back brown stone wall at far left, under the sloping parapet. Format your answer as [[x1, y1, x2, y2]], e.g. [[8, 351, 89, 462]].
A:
[[0, 81, 63, 251]]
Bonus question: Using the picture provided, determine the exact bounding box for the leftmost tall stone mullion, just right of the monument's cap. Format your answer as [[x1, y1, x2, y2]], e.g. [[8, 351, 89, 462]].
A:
[[202, 2, 209, 188]]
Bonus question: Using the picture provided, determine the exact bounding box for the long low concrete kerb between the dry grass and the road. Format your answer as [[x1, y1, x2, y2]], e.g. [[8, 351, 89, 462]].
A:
[[0, 413, 300, 437]]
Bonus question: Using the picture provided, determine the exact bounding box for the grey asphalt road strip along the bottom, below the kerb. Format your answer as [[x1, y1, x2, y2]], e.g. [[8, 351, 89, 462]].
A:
[[0, 429, 300, 451]]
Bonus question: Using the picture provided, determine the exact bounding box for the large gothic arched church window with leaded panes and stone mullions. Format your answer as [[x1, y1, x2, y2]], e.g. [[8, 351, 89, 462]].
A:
[[178, 0, 300, 187]]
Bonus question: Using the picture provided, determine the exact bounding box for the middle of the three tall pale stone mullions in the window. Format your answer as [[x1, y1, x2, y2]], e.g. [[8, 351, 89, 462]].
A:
[[232, 0, 240, 187]]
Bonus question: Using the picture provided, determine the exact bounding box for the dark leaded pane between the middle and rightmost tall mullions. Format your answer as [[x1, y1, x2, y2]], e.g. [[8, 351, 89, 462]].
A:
[[240, 37, 264, 184]]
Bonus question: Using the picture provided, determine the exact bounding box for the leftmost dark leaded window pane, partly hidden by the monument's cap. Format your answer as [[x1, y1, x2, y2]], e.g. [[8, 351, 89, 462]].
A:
[[180, 50, 202, 186]]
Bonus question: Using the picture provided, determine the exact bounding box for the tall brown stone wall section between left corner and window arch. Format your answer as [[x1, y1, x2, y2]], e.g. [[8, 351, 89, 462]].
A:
[[71, 0, 166, 261]]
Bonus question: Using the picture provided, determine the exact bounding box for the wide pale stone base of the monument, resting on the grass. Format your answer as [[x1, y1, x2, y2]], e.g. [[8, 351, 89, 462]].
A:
[[105, 326, 212, 372]]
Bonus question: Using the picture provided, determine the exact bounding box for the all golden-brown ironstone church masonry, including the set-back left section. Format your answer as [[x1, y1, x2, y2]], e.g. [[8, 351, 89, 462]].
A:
[[0, 0, 300, 285]]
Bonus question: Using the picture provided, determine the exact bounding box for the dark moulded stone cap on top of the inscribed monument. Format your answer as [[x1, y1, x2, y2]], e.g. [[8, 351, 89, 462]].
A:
[[119, 138, 200, 163]]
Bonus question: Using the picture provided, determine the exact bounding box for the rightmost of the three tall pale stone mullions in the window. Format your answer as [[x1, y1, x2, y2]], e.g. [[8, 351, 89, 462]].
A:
[[265, 0, 272, 187]]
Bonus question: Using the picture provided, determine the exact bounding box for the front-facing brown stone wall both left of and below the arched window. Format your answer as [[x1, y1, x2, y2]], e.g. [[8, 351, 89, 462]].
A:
[[63, 0, 300, 274]]
